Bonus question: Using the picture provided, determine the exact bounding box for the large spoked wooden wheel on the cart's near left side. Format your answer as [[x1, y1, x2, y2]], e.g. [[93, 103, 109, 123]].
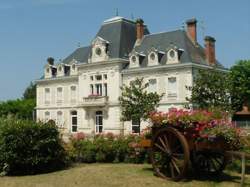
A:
[[151, 127, 189, 181]]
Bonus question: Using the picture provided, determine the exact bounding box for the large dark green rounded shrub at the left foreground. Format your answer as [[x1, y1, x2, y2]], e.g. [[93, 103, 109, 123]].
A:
[[0, 119, 67, 175]]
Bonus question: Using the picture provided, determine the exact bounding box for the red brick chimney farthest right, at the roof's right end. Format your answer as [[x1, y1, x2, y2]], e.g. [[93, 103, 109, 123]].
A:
[[204, 36, 216, 65]]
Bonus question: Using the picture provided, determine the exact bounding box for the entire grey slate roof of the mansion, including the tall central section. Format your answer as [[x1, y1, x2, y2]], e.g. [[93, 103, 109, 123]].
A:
[[60, 17, 223, 68]]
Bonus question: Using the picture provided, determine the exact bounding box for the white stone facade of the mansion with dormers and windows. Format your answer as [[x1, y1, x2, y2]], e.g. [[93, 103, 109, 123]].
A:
[[36, 18, 225, 134]]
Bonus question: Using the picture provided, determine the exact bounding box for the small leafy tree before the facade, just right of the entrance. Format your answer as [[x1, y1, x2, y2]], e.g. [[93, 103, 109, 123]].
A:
[[119, 78, 163, 133]]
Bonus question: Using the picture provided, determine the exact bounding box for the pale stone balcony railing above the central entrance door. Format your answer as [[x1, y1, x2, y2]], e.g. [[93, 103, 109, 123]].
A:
[[82, 95, 109, 107]]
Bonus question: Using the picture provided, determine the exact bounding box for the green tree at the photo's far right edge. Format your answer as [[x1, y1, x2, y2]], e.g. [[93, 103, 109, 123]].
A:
[[229, 60, 250, 111]]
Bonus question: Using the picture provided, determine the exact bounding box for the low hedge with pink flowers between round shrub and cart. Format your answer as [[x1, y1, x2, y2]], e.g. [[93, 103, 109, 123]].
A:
[[68, 132, 147, 163]]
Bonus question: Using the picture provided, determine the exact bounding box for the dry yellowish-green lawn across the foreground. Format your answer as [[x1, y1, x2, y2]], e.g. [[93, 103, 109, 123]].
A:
[[0, 164, 250, 187]]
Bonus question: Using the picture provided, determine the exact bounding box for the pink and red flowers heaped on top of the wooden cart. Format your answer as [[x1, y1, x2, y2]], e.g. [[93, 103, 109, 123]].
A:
[[149, 109, 239, 148]]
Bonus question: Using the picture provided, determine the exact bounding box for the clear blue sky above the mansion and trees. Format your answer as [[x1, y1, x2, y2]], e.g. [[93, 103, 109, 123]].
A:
[[0, 0, 250, 101]]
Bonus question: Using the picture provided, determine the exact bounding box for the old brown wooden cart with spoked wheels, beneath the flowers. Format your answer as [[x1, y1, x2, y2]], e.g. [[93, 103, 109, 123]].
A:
[[141, 126, 227, 181]]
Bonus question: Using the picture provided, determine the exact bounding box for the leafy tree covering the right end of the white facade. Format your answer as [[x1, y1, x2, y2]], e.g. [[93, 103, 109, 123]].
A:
[[186, 69, 231, 112]]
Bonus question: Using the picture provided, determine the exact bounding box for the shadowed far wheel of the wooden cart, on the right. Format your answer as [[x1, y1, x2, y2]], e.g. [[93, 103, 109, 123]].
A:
[[192, 150, 226, 176]]
